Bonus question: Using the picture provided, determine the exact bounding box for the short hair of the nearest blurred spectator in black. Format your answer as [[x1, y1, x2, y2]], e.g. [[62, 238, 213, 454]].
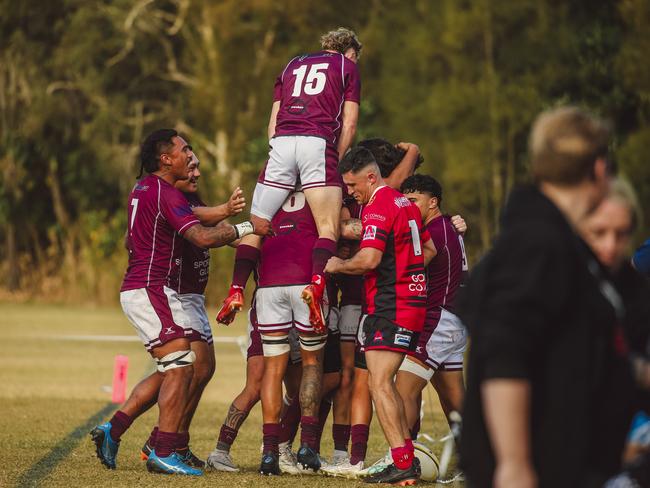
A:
[[528, 107, 611, 185]]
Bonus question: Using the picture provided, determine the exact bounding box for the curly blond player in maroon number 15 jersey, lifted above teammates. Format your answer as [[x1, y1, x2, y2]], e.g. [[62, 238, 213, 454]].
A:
[[217, 28, 361, 334]]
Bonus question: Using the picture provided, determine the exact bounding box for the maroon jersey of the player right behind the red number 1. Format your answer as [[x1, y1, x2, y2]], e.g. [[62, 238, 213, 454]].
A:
[[427, 215, 467, 317]]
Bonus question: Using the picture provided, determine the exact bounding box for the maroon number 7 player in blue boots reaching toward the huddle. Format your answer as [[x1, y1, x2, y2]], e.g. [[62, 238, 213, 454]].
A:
[[91, 129, 269, 475]]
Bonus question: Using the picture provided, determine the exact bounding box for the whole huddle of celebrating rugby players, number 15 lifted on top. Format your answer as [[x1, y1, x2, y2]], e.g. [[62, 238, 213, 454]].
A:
[[91, 28, 467, 485]]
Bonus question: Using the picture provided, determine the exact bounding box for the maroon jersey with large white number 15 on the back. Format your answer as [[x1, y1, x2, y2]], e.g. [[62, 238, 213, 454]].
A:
[[273, 51, 361, 144]]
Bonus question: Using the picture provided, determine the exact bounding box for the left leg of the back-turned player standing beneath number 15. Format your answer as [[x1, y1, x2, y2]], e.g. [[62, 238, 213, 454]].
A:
[[260, 332, 290, 475]]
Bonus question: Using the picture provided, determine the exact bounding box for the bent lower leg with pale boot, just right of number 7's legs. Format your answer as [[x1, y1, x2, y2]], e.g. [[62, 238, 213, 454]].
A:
[[208, 356, 264, 471]]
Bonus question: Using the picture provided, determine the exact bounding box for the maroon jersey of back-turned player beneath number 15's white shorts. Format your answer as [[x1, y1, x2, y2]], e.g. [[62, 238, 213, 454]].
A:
[[258, 191, 318, 288]]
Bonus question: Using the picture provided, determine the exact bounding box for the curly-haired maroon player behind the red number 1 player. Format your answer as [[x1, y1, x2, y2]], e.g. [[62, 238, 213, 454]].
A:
[[396, 174, 468, 468]]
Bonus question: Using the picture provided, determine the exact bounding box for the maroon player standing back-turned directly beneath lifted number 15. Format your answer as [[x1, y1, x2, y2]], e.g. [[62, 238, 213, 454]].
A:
[[255, 191, 334, 474]]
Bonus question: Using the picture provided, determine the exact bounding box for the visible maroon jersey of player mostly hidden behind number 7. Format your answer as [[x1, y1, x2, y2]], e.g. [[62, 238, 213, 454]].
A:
[[172, 193, 210, 295]]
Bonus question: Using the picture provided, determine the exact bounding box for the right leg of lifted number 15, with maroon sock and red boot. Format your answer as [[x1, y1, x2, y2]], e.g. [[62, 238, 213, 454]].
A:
[[302, 186, 343, 334]]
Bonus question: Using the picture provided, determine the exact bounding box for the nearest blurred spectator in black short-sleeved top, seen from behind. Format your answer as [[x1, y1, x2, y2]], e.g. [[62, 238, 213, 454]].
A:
[[460, 108, 634, 488]]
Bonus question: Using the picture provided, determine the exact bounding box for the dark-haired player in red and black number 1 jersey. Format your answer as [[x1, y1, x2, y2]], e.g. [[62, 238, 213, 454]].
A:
[[325, 147, 435, 483]]
